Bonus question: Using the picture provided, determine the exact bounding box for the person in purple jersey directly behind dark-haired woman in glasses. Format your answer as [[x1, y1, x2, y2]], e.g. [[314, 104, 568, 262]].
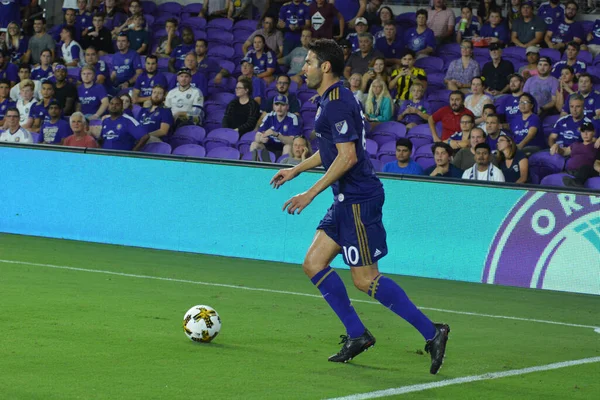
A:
[[509, 93, 544, 154]]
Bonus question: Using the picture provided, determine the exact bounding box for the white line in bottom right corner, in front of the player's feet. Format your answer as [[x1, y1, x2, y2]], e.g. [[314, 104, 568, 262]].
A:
[[328, 357, 600, 400]]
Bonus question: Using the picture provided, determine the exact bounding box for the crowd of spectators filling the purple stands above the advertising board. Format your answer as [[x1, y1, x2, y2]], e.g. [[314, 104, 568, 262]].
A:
[[0, 0, 600, 186]]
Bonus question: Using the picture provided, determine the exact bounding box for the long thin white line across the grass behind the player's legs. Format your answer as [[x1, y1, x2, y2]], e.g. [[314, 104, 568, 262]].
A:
[[0, 259, 600, 333]]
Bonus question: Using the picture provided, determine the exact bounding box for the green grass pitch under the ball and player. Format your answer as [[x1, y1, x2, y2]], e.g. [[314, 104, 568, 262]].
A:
[[0, 234, 600, 400]]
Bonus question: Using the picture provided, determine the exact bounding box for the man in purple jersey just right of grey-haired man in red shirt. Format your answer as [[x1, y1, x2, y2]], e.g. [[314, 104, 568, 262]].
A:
[[100, 96, 144, 150]]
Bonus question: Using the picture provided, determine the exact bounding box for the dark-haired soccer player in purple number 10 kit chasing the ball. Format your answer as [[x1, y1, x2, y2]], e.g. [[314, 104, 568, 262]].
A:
[[271, 39, 450, 374]]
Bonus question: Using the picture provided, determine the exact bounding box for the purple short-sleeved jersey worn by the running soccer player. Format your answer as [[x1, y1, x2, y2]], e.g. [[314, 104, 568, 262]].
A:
[[315, 82, 383, 203]]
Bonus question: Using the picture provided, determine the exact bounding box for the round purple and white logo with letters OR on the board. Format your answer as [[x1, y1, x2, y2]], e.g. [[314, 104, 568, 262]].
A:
[[481, 192, 600, 294]]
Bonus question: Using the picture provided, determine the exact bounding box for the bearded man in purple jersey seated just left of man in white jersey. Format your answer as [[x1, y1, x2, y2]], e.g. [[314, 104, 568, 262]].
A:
[[134, 85, 174, 150]]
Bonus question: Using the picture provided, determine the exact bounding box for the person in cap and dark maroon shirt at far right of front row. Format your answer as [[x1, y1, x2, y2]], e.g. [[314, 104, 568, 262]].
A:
[[550, 122, 600, 187]]
